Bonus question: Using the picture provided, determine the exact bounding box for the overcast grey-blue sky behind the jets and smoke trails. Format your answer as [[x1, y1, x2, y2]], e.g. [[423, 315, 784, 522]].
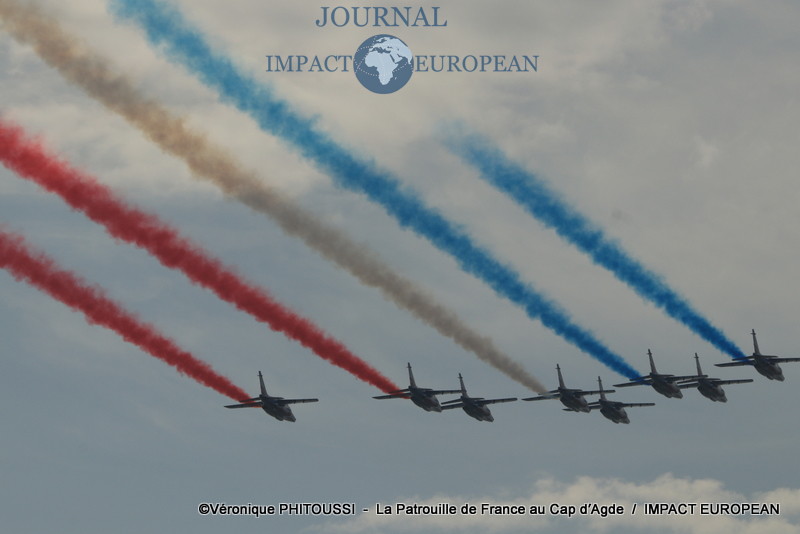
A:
[[0, 0, 800, 534]]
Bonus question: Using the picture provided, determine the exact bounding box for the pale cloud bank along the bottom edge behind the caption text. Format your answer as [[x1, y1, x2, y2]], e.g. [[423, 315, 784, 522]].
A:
[[316, 473, 800, 534]]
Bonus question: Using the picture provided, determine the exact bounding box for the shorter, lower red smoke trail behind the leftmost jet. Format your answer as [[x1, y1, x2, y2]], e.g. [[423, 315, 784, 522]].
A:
[[0, 228, 249, 400]]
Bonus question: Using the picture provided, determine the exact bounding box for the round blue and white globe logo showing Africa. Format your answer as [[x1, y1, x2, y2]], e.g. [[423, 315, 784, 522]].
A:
[[353, 34, 414, 95]]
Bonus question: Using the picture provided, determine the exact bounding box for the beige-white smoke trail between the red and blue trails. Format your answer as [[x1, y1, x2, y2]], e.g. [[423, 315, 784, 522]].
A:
[[0, 0, 546, 393]]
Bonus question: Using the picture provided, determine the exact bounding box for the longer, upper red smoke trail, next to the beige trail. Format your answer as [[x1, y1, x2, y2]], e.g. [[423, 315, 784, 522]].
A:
[[0, 119, 399, 398]]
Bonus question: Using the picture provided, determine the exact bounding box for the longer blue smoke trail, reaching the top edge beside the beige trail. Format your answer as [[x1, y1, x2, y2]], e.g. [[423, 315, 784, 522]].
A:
[[110, 0, 639, 378]]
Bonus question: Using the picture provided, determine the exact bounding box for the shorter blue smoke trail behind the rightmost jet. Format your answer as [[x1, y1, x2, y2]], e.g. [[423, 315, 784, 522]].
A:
[[444, 124, 745, 359]]
